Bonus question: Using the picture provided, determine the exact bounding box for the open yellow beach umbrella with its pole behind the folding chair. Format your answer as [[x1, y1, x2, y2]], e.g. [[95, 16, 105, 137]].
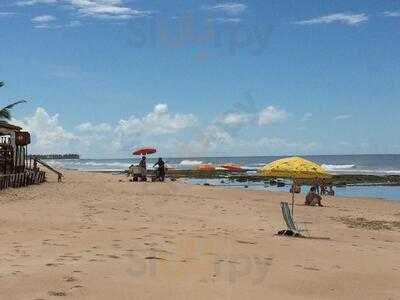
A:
[[259, 156, 332, 214]]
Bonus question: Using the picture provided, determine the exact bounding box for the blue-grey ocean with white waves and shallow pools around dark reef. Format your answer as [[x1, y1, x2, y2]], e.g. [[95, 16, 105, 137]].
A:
[[47, 154, 400, 201]]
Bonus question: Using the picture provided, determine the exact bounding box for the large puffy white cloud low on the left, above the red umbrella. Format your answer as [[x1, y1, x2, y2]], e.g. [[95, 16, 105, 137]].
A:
[[12, 104, 197, 156]]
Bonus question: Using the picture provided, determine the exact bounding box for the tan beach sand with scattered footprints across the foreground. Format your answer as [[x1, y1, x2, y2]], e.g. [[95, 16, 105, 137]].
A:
[[0, 171, 400, 300]]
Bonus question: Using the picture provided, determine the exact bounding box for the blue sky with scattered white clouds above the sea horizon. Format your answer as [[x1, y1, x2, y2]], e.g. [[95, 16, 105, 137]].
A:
[[0, 0, 400, 158]]
